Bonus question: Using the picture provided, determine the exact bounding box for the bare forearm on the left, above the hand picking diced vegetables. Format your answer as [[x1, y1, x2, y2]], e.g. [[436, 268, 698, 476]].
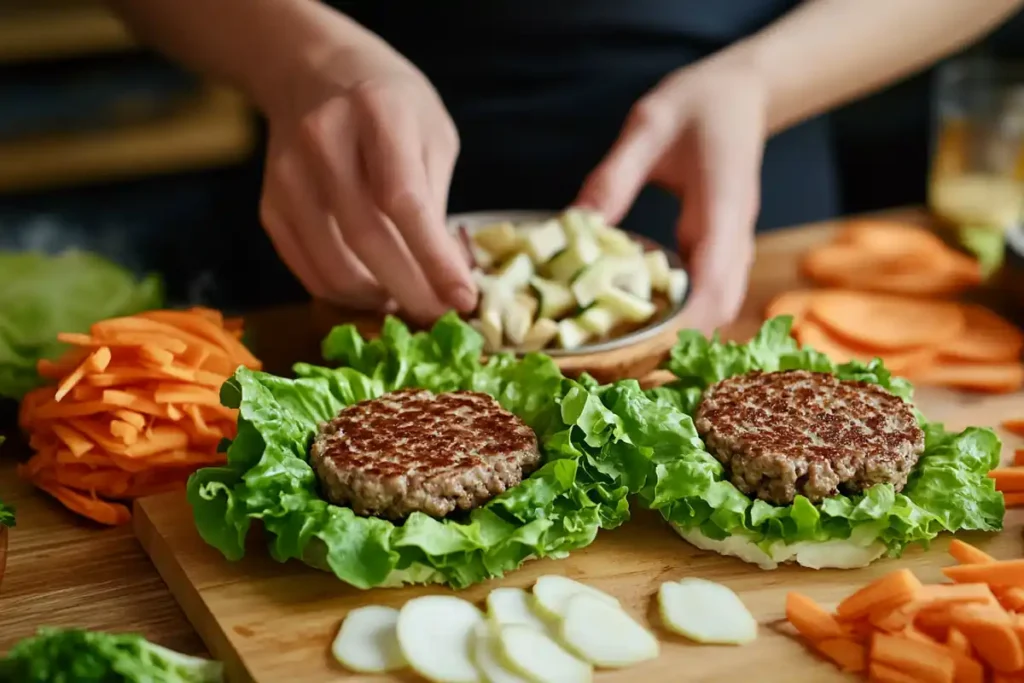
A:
[[109, 0, 379, 111]]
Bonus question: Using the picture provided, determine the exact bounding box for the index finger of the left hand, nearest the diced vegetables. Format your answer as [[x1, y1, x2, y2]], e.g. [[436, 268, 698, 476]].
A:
[[357, 91, 476, 311]]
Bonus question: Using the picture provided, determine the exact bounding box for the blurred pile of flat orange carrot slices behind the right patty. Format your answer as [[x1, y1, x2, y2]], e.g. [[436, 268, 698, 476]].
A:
[[765, 221, 1024, 393]]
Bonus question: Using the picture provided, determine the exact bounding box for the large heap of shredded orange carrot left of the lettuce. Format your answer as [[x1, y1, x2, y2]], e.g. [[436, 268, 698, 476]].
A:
[[18, 308, 260, 524]]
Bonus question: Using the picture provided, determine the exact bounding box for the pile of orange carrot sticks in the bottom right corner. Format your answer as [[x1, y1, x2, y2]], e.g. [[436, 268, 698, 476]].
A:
[[785, 540, 1024, 683]]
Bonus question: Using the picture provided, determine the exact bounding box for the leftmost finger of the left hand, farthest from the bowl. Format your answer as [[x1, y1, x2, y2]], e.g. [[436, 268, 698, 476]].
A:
[[264, 145, 387, 309]]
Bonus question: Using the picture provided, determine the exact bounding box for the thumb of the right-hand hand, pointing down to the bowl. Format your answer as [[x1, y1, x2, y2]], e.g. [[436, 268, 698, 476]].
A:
[[573, 101, 674, 224]]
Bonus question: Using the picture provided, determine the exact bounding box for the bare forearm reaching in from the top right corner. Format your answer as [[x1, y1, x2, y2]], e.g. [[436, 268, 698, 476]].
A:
[[713, 0, 1024, 132]]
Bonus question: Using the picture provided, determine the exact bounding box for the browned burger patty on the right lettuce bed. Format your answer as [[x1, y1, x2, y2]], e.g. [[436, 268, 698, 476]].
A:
[[695, 370, 925, 505]]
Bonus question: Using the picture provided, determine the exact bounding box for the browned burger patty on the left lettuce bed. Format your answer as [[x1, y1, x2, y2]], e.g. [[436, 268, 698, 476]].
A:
[[310, 389, 541, 519]]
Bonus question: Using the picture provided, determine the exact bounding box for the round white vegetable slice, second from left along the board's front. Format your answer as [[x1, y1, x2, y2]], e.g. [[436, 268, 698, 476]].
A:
[[397, 595, 483, 683]]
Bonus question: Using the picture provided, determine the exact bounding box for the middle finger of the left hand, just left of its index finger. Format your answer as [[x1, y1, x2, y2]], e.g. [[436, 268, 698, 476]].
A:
[[302, 99, 447, 323]]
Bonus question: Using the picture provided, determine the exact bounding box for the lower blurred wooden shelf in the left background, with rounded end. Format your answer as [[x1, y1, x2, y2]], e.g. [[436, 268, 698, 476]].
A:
[[0, 86, 255, 193]]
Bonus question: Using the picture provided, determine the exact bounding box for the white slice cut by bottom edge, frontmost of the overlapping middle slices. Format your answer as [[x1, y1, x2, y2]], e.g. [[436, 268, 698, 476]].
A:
[[499, 624, 594, 683]]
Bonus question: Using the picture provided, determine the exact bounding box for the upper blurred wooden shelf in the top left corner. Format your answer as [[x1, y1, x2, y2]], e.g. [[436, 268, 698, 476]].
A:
[[0, 1, 136, 63]]
